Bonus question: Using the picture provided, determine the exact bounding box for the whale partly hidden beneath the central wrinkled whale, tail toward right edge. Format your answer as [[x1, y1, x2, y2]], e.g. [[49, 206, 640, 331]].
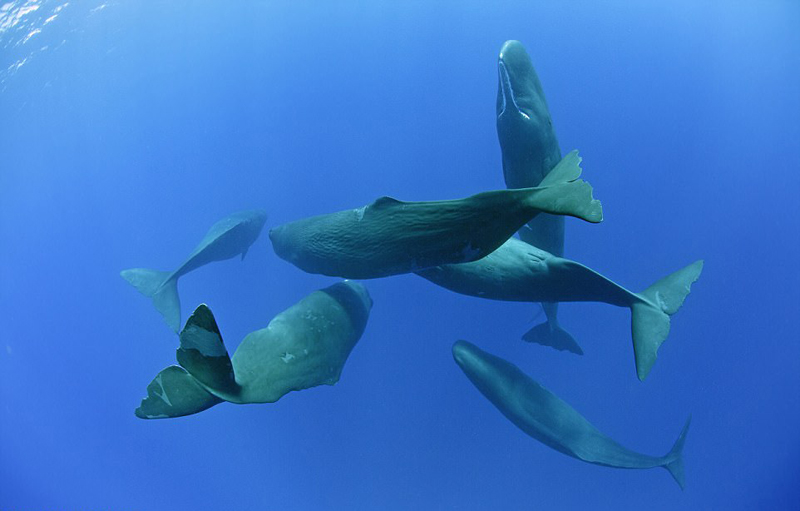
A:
[[416, 238, 703, 380]]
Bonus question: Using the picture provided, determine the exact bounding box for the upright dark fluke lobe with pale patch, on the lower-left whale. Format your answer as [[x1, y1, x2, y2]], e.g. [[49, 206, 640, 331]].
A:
[[176, 304, 238, 395]]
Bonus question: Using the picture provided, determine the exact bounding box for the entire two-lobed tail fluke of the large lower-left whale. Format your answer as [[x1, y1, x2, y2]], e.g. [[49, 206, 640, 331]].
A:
[[135, 304, 239, 419]]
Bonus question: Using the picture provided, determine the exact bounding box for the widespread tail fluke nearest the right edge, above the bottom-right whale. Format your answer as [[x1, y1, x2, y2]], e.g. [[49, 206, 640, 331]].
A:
[[631, 260, 703, 381]]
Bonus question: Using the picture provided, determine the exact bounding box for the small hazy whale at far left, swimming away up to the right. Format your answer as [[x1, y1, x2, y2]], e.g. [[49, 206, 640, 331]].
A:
[[120, 210, 267, 332]]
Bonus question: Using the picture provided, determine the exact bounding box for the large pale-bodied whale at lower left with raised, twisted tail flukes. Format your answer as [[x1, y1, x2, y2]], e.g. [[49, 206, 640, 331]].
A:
[[136, 281, 372, 419]]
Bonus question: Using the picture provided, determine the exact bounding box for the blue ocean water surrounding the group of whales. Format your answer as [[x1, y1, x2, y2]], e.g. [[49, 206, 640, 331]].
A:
[[0, 0, 800, 510]]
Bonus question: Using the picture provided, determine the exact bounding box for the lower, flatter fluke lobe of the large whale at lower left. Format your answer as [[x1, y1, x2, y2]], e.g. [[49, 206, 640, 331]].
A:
[[135, 366, 222, 419]]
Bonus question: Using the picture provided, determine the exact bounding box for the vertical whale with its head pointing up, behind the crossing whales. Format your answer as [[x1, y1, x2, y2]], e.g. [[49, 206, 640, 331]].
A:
[[497, 41, 578, 351]]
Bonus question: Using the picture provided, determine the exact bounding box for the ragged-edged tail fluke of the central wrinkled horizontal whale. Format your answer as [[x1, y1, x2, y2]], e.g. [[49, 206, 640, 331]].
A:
[[528, 150, 603, 223]]
